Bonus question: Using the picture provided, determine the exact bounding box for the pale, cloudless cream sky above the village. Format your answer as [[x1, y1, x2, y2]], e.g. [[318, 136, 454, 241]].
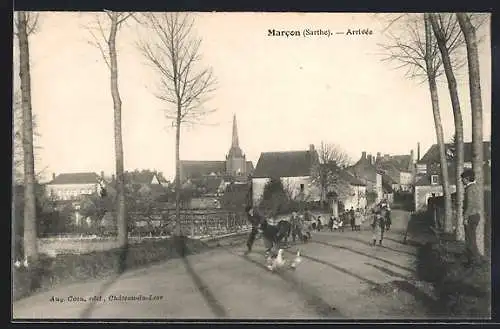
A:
[[13, 12, 491, 179]]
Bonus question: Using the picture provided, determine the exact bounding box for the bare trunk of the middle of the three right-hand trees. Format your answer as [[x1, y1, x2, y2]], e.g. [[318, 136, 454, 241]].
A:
[[429, 14, 465, 241]]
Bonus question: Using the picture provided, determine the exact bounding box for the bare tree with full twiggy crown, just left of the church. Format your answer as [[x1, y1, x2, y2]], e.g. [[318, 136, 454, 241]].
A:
[[138, 13, 215, 241]]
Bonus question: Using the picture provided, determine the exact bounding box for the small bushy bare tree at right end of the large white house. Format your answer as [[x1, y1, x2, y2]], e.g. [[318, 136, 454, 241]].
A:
[[312, 142, 351, 203]]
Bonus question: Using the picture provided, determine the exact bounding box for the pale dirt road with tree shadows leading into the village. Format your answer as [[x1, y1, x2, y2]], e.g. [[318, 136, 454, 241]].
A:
[[13, 211, 434, 319]]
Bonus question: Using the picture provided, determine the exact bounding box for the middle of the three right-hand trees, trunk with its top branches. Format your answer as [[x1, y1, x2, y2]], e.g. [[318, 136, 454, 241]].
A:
[[429, 14, 465, 241]]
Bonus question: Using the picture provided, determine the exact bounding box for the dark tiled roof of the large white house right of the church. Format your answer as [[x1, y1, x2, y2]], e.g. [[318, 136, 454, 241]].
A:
[[253, 151, 313, 178]]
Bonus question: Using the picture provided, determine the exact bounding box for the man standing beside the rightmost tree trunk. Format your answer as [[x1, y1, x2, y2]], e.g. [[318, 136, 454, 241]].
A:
[[461, 169, 482, 266]]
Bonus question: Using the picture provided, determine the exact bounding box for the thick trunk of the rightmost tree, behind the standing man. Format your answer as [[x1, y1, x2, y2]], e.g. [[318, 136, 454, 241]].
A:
[[457, 13, 485, 255]]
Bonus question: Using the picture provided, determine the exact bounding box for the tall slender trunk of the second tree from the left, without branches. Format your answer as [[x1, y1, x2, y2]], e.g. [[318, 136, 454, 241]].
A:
[[108, 14, 128, 248]]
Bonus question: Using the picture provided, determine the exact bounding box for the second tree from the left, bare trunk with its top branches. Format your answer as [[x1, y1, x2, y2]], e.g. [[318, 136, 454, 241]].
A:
[[89, 11, 133, 248]]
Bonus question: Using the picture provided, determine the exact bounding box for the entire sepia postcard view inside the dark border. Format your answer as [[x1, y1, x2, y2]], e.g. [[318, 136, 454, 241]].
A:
[[10, 10, 492, 322]]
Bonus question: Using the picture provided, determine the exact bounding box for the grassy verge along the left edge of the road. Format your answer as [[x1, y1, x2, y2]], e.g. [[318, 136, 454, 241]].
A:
[[13, 234, 246, 301]]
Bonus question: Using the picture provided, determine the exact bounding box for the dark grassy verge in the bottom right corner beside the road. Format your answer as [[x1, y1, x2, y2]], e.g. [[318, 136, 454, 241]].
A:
[[416, 240, 491, 319]]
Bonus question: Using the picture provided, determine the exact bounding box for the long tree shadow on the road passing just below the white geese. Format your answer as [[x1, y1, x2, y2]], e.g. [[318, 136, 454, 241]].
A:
[[217, 243, 345, 319]]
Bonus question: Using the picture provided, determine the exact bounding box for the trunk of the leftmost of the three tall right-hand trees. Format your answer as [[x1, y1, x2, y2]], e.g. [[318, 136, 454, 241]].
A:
[[424, 13, 453, 232]]
